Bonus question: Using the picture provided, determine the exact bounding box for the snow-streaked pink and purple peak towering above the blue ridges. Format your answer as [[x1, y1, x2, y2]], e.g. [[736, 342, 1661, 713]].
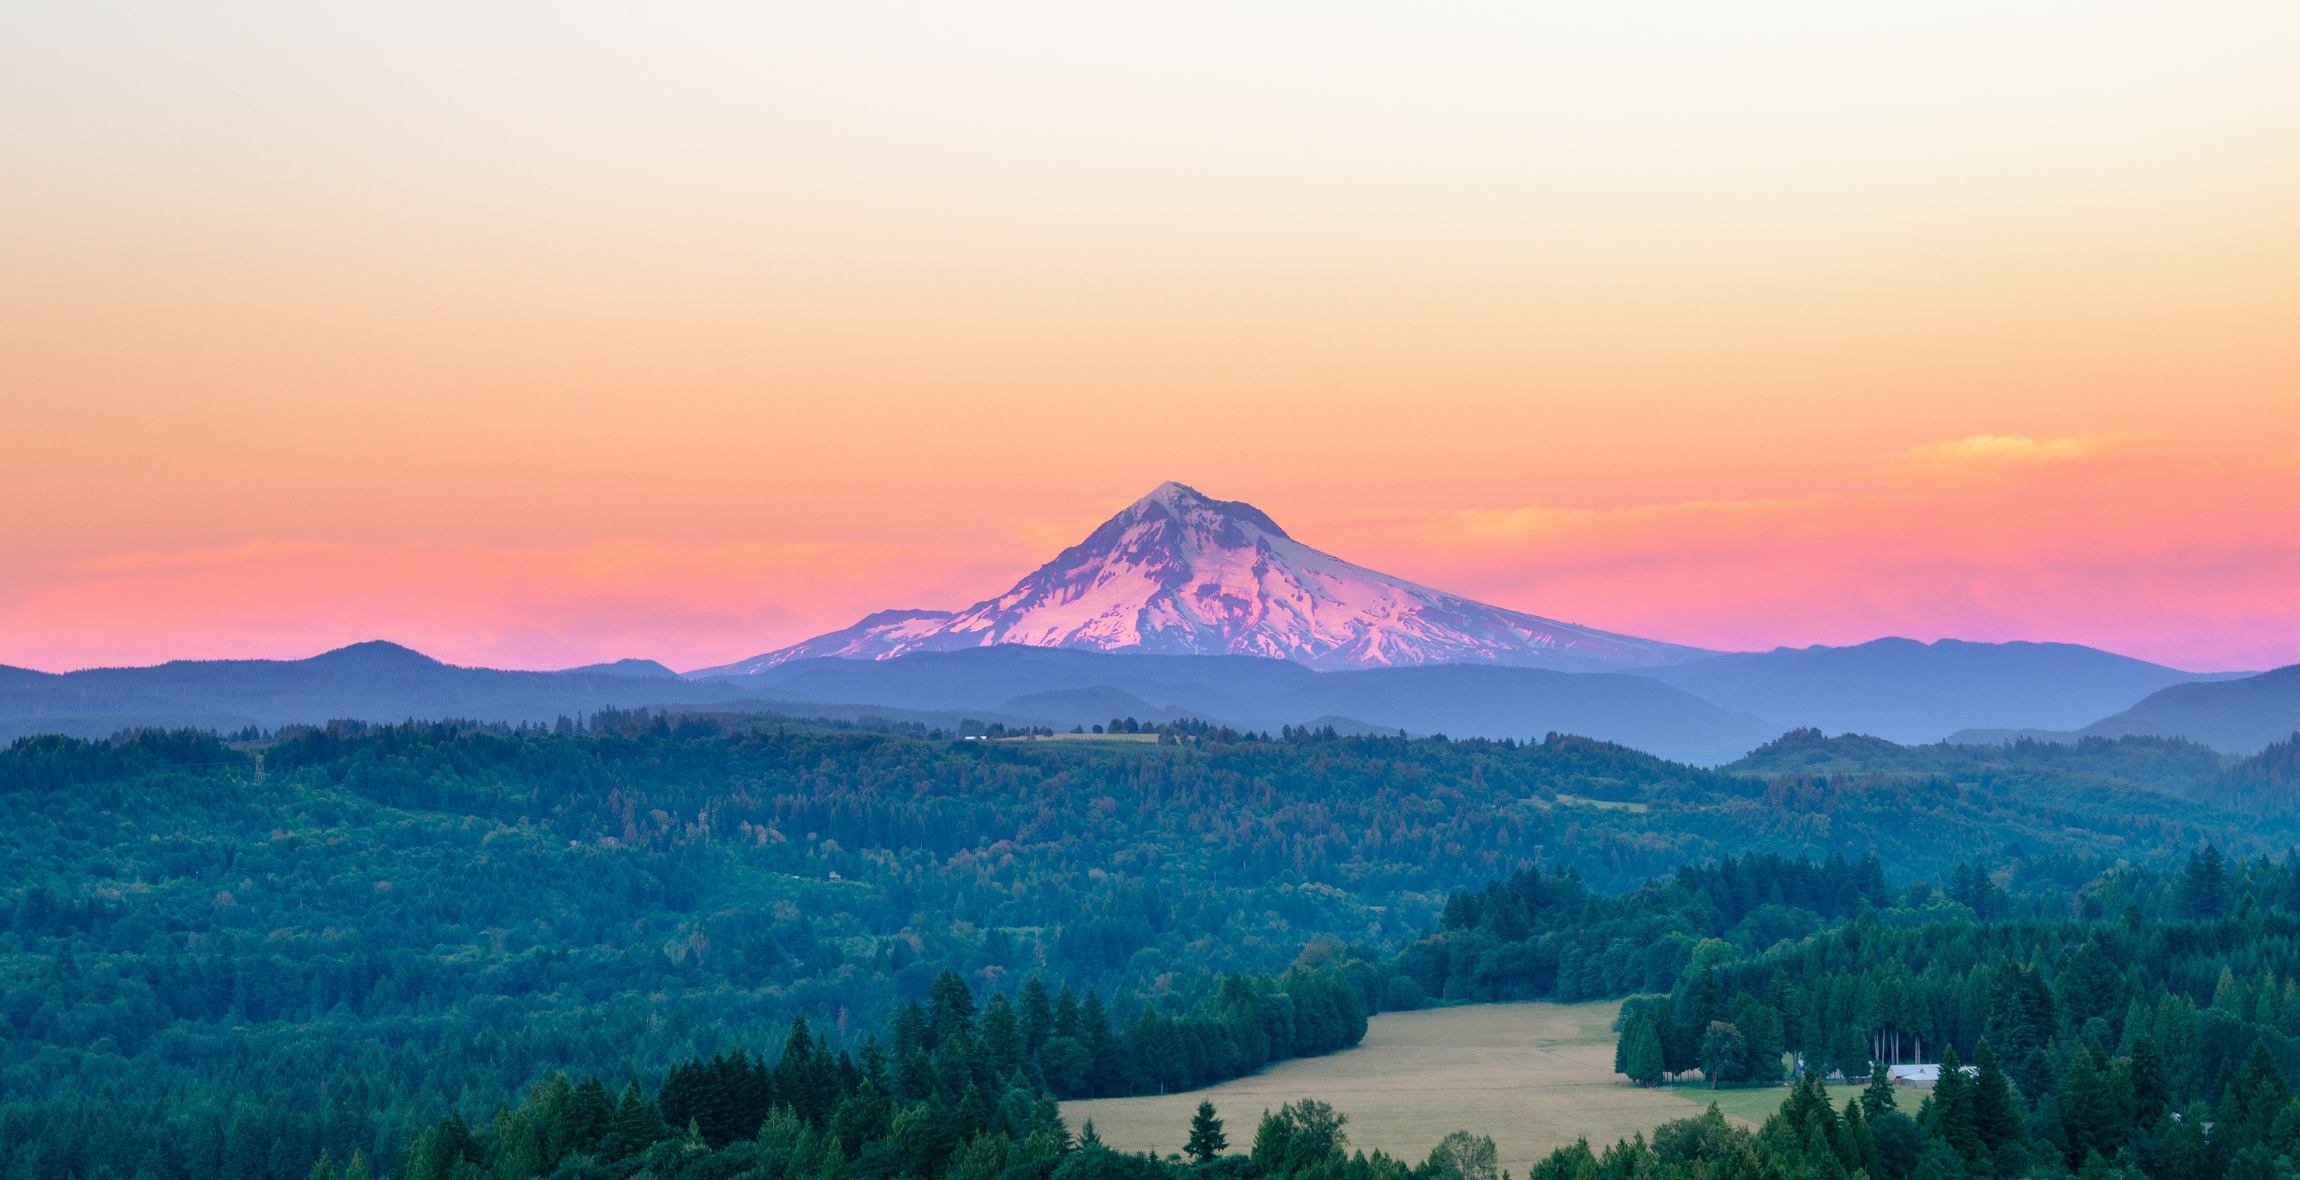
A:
[[688, 483, 1709, 676]]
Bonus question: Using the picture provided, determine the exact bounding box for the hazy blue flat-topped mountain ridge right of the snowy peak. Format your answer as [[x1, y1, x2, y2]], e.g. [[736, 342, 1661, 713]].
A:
[[1638, 637, 2252, 743]]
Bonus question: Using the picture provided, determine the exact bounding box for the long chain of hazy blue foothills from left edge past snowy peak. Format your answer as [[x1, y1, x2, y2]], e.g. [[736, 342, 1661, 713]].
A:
[[0, 642, 1778, 764]]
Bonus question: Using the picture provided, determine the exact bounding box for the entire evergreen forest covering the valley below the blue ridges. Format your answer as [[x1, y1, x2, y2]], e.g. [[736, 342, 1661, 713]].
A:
[[0, 711, 2300, 1180]]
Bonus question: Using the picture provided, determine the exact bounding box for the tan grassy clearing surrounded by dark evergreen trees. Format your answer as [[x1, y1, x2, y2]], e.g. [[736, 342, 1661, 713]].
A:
[[1063, 1001, 1812, 1175]]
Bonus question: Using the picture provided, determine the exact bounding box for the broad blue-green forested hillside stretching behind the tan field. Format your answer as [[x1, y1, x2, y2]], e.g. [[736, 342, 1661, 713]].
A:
[[13, 713, 2291, 1178]]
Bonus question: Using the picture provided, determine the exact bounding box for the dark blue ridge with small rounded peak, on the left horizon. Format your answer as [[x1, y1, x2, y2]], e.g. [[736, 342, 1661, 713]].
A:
[[0, 639, 745, 741]]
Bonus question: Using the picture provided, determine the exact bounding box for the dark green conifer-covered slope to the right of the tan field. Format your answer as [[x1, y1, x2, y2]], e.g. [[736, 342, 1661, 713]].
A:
[[1582, 849, 2300, 1180]]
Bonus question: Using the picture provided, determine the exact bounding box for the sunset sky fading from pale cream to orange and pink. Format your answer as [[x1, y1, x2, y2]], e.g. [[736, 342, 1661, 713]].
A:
[[0, 0, 2300, 672]]
